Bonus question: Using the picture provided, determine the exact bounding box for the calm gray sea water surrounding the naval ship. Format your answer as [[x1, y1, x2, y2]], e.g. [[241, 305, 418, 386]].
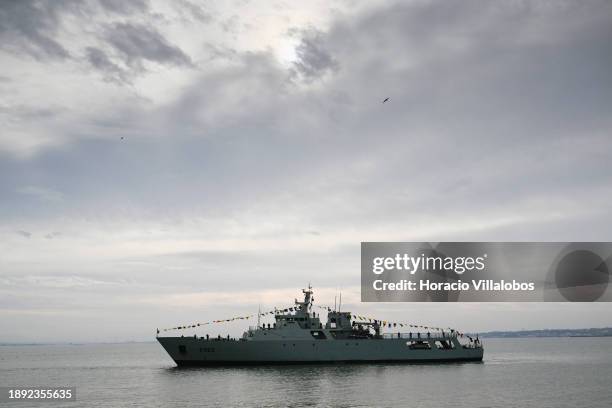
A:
[[0, 338, 612, 408]]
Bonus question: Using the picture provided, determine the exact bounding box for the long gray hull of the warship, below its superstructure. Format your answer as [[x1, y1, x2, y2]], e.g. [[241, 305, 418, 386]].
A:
[[157, 337, 483, 366]]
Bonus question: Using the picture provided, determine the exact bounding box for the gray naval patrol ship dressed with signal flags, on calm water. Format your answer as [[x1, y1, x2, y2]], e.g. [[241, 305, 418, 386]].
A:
[[157, 285, 483, 366]]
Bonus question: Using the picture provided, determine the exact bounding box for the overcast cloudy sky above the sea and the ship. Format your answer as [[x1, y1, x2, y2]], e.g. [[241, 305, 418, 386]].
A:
[[0, 0, 612, 342]]
